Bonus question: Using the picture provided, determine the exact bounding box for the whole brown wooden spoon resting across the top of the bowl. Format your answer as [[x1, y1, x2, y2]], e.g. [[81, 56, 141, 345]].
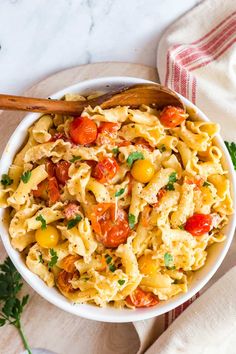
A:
[[0, 84, 184, 116]]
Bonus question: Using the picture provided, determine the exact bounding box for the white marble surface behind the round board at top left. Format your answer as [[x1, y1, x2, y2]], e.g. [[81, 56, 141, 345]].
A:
[[0, 0, 199, 94]]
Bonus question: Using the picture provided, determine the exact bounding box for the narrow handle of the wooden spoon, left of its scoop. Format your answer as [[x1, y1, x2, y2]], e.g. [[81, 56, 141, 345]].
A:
[[0, 94, 88, 116]]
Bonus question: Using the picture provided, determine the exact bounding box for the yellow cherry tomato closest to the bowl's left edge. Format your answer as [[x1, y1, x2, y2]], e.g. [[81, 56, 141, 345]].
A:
[[35, 225, 59, 248]]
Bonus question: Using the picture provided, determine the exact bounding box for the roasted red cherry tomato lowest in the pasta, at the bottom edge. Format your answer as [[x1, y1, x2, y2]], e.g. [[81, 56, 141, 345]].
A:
[[125, 287, 159, 307]]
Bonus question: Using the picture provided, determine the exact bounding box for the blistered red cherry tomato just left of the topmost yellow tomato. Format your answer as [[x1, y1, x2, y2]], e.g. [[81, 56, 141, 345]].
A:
[[92, 157, 119, 183]]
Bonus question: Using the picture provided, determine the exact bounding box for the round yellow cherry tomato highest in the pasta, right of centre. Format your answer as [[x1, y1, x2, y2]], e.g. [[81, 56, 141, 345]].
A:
[[131, 160, 155, 183]]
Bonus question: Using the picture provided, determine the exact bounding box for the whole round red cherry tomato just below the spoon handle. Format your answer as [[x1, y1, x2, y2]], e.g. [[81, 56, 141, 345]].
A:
[[69, 117, 97, 145]]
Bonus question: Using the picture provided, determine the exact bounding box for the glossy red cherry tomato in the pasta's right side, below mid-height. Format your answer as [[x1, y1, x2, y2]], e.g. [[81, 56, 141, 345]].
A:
[[184, 214, 212, 236]]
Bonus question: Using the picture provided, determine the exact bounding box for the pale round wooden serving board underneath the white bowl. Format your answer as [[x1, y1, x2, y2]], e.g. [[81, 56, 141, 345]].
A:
[[0, 62, 158, 354]]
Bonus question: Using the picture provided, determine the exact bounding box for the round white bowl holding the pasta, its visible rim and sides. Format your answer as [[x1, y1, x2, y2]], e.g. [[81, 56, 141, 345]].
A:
[[0, 77, 236, 322]]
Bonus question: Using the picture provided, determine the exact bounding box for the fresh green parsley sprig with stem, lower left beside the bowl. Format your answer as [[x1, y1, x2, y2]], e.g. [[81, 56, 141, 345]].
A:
[[0, 257, 32, 354]]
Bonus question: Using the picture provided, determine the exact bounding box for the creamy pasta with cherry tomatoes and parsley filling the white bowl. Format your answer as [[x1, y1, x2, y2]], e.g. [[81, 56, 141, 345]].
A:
[[0, 94, 233, 309]]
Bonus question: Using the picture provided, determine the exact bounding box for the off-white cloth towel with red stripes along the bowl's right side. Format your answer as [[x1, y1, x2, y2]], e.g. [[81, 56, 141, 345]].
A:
[[134, 0, 236, 354]]
